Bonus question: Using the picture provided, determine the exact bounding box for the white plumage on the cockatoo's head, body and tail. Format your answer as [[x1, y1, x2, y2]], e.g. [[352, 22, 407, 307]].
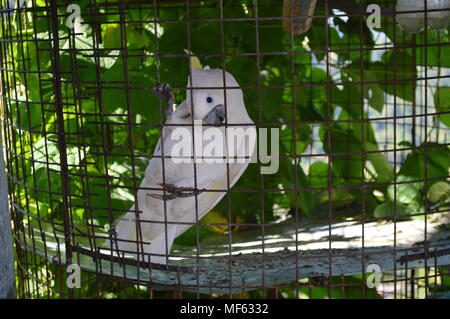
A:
[[112, 69, 255, 263]]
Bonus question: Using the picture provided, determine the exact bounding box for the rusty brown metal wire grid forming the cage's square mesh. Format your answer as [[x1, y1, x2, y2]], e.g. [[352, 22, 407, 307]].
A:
[[1, 0, 449, 297]]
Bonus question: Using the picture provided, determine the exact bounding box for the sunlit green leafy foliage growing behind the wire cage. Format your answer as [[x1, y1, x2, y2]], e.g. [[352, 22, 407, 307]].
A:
[[1, 0, 450, 300]]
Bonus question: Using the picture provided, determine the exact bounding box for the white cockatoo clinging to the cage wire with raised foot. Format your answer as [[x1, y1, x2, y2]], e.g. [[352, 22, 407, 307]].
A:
[[107, 66, 256, 265]]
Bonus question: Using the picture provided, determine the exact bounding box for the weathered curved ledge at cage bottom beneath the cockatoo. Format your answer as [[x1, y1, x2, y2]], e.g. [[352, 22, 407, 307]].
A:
[[17, 214, 450, 294]]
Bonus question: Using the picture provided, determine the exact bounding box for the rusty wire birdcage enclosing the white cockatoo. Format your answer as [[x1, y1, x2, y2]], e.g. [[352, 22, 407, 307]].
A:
[[0, 0, 450, 298]]
